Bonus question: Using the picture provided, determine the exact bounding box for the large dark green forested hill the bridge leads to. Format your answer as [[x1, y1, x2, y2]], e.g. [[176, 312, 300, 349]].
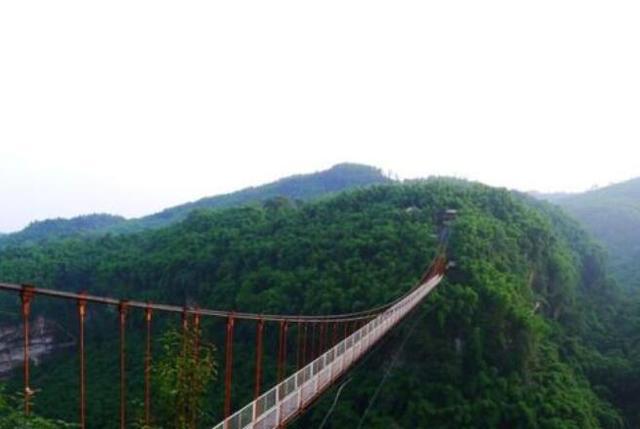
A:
[[0, 179, 640, 429]]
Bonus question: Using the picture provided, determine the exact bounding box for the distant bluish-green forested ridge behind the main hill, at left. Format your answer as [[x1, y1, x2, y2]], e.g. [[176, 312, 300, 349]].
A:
[[0, 163, 391, 248]]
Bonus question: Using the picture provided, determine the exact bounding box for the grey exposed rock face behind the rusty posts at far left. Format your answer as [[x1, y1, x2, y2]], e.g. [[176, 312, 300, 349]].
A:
[[0, 317, 75, 377]]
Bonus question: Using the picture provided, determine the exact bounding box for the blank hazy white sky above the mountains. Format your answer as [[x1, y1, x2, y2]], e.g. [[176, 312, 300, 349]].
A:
[[0, 0, 640, 232]]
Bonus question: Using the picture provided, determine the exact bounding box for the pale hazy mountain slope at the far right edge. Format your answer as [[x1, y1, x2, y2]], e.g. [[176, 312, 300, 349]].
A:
[[550, 178, 640, 290]]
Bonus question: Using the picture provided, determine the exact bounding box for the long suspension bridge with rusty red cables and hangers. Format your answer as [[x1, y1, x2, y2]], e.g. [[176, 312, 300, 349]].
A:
[[0, 211, 455, 429]]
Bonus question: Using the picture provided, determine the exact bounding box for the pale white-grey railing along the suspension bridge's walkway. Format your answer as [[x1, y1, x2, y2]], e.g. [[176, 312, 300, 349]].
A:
[[213, 275, 442, 429]]
